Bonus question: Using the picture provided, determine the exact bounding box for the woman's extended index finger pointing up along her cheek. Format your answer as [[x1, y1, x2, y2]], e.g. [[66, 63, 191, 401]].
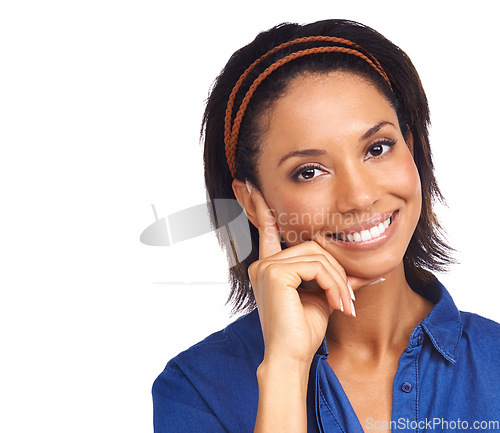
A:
[[247, 183, 282, 259]]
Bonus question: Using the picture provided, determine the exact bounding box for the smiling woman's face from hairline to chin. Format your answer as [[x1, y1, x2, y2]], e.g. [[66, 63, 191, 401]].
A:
[[257, 72, 421, 278]]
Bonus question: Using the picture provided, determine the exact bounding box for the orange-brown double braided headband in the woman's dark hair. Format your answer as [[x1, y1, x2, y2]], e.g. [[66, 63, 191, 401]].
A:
[[224, 36, 392, 178]]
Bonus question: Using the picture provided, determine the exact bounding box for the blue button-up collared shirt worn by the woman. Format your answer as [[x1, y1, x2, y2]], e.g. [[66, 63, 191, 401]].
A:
[[153, 281, 500, 433]]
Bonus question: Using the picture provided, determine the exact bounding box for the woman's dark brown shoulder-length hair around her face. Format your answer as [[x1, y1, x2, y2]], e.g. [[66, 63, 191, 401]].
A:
[[202, 20, 453, 311]]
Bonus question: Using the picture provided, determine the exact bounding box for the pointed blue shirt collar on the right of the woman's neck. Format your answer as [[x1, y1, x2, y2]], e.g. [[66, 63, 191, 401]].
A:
[[316, 279, 462, 363]]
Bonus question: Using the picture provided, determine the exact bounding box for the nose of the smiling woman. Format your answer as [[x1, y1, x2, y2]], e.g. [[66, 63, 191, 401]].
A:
[[333, 165, 380, 214]]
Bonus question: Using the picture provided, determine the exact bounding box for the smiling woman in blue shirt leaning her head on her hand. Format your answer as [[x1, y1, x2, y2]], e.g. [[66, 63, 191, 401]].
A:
[[153, 20, 500, 432]]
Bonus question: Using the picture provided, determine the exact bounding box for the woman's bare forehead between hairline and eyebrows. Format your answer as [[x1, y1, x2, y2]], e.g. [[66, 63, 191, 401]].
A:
[[262, 71, 397, 147]]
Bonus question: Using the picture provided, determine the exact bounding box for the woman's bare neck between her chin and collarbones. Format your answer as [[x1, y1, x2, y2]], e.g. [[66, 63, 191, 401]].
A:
[[326, 266, 434, 360]]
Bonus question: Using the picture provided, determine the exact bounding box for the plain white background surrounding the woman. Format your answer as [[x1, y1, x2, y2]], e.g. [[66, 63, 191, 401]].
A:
[[0, 0, 500, 433]]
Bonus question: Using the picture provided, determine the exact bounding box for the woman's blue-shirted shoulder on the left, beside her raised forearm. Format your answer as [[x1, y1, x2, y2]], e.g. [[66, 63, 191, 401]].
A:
[[153, 310, 264, 432]]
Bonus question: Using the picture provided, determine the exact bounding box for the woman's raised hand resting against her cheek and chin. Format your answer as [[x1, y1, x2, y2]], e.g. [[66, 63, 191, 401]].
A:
[[248, 188, 372, 367]]
